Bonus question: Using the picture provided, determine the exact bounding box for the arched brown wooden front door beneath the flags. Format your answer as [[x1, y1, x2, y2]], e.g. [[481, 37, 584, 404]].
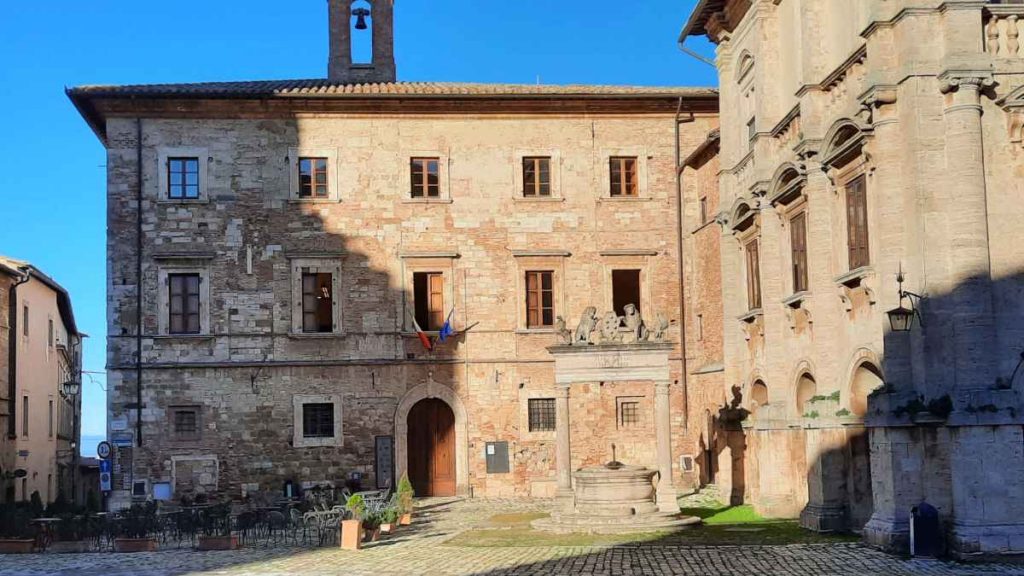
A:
[[408, 399, 455, 496]]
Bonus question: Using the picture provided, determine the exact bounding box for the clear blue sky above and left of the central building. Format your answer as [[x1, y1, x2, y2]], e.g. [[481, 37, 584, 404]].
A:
[[0, 0, 716, 435]]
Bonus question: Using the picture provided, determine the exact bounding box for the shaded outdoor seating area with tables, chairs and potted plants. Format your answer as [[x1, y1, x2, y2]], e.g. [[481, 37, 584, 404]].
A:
[[0, 479, 413, 553]]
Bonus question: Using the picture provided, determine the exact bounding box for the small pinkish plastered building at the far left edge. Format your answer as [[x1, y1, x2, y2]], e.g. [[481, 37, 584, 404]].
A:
[[0, 256, 82, 503]]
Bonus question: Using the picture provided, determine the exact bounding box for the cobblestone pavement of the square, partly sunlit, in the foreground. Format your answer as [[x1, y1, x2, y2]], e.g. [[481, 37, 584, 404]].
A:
[[0, 501, 1024, 576]]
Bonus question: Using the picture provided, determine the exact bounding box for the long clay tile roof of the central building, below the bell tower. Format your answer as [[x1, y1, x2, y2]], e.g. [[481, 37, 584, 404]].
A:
[[68, 79, 718, 98]]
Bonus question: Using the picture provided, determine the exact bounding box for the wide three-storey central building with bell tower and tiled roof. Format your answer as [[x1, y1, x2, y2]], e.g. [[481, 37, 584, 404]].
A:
[[70, 0, 717, 501]]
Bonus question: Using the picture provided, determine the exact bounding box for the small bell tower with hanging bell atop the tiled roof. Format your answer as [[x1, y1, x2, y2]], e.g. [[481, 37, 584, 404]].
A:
[[327, 0, 396, 84]]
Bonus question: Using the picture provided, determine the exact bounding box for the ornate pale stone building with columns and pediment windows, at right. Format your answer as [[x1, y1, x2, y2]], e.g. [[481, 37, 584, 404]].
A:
[[681, 0, 1024, 557]]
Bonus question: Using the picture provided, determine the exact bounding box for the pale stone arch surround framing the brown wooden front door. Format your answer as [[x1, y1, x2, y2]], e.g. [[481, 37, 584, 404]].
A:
[[394, 381, 469, 496]]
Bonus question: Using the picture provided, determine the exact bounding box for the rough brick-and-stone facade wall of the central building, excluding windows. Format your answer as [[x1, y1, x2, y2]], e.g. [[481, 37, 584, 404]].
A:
[[101, 109, 716, 496]]
